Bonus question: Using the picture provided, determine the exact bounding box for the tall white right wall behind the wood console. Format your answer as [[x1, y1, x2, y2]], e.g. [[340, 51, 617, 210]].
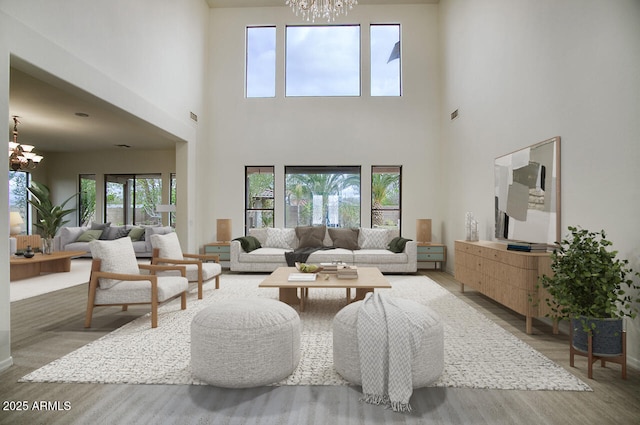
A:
[[440, 0, 640, 367]]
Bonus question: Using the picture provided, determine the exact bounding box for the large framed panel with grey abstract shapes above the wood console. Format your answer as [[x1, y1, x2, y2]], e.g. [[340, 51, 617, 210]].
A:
[[494, 137, 560, 245]]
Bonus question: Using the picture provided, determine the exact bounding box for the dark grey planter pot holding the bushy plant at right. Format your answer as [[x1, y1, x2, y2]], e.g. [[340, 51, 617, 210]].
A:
[[571, 317, 622, 356]]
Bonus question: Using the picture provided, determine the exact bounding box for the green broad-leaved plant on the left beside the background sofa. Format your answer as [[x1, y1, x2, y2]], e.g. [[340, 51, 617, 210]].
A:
[[27, 182, 77, 254]]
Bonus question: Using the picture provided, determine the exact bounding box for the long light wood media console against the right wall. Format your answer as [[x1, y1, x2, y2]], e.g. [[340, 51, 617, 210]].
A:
[[455, 241, 558, 334]]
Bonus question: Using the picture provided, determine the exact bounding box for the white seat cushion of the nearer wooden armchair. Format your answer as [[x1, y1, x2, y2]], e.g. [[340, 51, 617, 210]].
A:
[[96, 276, 189, 304]]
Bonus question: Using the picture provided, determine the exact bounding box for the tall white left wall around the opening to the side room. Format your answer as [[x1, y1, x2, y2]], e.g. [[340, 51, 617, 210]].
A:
[[0, 0, 209, 370]]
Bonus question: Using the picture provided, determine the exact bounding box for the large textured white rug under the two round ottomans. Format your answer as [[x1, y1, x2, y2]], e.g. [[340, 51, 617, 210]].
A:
[[21, 275, 591, 391]]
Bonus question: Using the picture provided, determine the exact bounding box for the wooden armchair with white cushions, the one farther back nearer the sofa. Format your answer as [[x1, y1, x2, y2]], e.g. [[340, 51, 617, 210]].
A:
[[150, 232, 222, 300]]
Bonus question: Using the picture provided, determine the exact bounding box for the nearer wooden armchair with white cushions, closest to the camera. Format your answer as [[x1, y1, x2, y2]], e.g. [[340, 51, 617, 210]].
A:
[[84, 238, 189, 328]]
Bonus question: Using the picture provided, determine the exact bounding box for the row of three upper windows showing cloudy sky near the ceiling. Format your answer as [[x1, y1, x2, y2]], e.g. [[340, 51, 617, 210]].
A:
[[245, 24, 402, 98]]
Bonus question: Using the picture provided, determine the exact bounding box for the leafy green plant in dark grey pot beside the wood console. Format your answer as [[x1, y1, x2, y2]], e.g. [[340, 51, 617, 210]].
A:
[[540, 226, 640, 355]]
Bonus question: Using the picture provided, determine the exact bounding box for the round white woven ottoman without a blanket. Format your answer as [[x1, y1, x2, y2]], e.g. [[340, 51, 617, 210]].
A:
[[191, 298, 300, 388]]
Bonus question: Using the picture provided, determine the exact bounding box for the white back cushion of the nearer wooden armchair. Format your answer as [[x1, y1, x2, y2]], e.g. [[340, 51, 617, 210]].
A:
[[89, 238, 140, 289]]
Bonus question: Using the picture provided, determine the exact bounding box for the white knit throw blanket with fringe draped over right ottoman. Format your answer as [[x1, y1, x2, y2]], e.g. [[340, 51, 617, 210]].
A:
[[357, 292, 422, 412]]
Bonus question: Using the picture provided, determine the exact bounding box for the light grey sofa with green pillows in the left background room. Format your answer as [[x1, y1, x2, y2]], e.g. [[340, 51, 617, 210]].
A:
[[53, 225, 174, 258]]
